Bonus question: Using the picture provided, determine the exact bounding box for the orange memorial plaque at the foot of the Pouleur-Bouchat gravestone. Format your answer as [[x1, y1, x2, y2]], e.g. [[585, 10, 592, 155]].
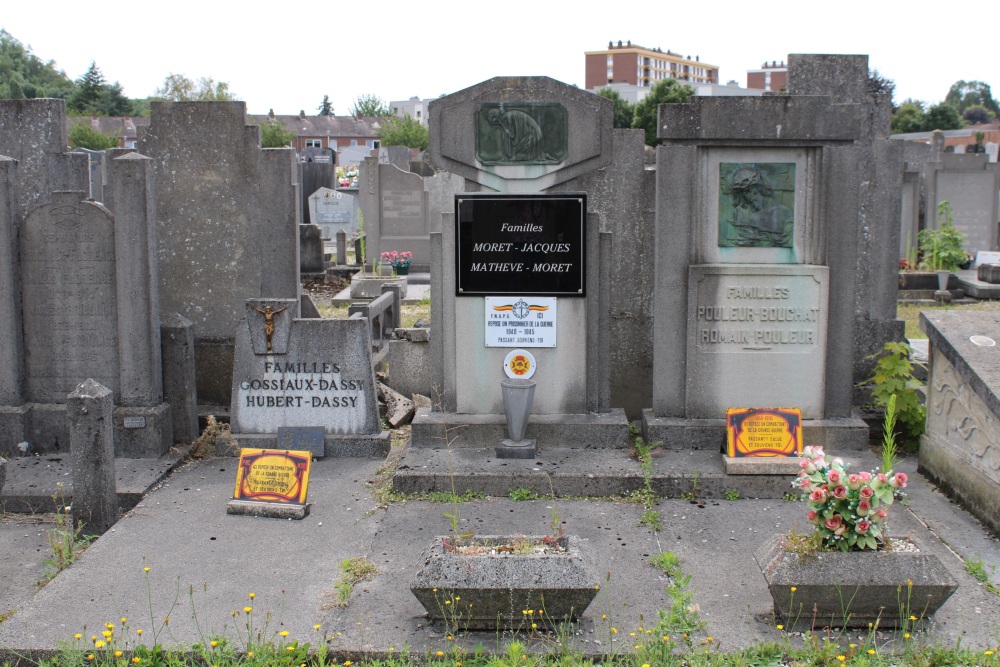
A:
[[726, 408, 802, 457]]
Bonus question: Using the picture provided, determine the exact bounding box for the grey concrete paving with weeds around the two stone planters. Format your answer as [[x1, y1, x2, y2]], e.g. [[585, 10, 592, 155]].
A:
[[0, 431, 1000, 667]]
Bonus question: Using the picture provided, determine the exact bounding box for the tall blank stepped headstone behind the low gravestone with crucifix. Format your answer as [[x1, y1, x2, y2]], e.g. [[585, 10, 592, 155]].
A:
[[139, 102, 300, 405]]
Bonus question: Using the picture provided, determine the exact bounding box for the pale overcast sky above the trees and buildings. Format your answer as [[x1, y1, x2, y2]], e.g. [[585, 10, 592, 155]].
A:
[[0, 0, 1000, 114]]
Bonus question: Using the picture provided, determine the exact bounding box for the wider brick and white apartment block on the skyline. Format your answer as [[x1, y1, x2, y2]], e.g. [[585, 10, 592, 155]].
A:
[[584, 40, 719, 90]]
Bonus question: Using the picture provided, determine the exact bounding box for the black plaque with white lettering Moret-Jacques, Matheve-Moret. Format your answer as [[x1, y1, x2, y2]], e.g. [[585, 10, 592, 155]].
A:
[[455, 194, 587, 297]]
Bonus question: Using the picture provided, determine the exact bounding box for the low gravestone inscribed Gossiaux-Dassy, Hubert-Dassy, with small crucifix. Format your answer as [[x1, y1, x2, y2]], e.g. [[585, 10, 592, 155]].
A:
[[231, 299, 389, 457]]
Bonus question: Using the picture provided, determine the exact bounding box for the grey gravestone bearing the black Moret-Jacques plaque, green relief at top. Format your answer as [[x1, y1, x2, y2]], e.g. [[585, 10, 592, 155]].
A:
[[414, 77, 627, 448]]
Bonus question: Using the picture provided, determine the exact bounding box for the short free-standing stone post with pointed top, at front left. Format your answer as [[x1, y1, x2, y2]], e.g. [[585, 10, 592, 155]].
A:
[[66, 379, 118, 535]]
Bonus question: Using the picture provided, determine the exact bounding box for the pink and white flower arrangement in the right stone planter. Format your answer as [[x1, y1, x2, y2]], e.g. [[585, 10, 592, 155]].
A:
[[792, 447, 907, 551]]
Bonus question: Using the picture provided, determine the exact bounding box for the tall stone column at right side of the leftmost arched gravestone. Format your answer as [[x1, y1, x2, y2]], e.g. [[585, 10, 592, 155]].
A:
[[104, 153, 163, 407]]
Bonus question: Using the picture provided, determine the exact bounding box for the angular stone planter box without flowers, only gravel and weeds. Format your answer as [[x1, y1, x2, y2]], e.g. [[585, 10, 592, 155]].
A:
[[410, 535, 600, 631]]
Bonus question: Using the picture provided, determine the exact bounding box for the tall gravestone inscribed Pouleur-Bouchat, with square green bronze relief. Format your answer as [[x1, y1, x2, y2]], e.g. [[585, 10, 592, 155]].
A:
[[643, 55, 902, 449]]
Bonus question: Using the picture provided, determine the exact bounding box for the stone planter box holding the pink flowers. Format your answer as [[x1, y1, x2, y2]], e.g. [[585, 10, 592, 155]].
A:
[[754, 535, 958, 630]]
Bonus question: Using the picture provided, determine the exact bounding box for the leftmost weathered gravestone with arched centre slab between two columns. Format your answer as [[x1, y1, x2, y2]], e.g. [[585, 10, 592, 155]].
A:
[[0, 100, 185, 457]]
